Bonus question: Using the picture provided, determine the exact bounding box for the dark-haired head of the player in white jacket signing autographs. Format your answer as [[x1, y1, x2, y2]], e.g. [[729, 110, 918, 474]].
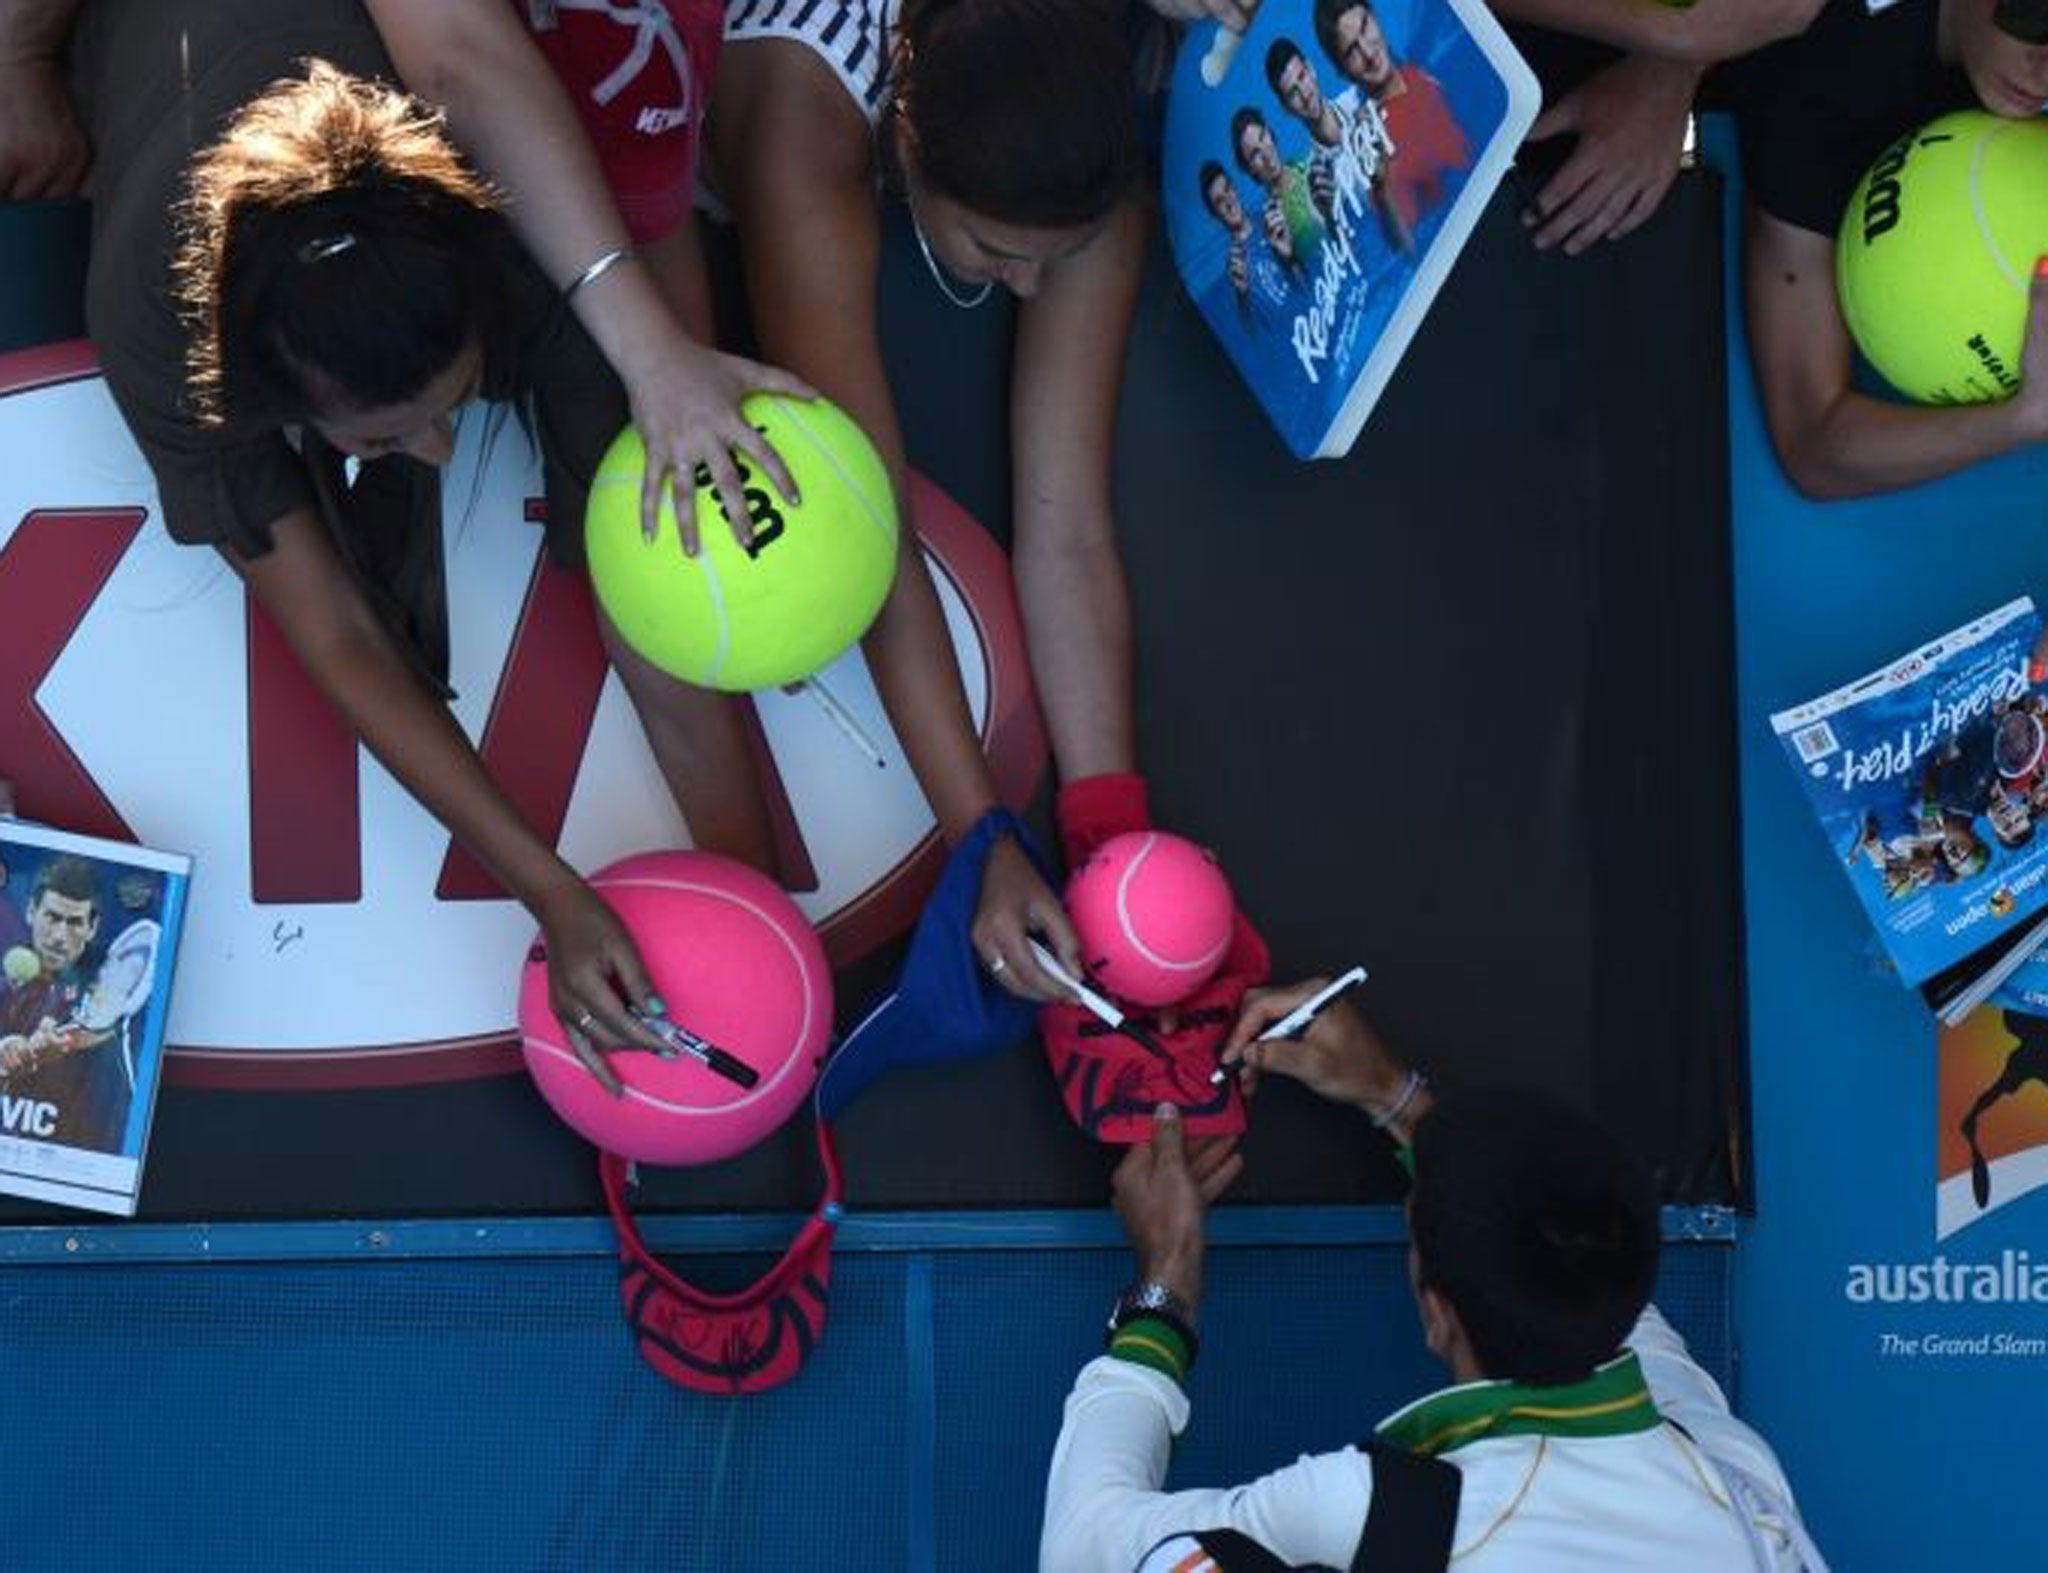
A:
[[1409, 1090, 1657, 1385]]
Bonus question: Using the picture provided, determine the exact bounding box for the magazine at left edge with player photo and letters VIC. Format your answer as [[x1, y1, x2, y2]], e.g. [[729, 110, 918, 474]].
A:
[[0, 819, 190, 1215]]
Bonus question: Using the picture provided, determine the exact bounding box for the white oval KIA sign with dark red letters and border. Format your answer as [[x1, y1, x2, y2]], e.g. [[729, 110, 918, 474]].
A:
[[0, 344, 1044, 1088]]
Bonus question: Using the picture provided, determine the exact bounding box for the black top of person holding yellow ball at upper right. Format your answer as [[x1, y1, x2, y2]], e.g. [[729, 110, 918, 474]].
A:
[[1729, 0, 1976, 236]]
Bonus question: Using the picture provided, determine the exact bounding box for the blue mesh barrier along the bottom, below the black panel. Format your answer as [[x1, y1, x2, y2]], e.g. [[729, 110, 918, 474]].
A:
[[0, 1208, 1733, 1573]]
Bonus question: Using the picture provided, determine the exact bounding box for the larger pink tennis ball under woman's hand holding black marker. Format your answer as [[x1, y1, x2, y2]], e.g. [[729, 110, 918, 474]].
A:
[[518, 852, 831, 1163]]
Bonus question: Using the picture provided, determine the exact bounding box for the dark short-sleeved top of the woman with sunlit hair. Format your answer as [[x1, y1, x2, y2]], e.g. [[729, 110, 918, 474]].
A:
[[70, 0, 629, 688]]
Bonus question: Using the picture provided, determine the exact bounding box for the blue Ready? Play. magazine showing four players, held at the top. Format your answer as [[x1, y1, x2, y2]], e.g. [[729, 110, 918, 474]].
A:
[[1161, 0, 1540, 459]]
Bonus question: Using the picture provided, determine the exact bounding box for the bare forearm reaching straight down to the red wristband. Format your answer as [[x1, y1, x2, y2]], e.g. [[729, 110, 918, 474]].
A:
[[1010, 201, 1147, 780]]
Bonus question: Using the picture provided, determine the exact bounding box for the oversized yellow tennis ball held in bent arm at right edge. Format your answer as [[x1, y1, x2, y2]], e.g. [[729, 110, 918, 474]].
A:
[[1835, 109, 2048, 403]]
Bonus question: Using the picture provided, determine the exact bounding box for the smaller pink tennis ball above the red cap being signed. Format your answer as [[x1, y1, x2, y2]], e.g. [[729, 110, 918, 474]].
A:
[[1067, 830, 1237, 1006]]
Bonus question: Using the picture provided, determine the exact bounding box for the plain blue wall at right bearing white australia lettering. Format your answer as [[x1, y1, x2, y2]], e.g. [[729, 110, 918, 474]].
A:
[[1712, 119, 2048, 1571]]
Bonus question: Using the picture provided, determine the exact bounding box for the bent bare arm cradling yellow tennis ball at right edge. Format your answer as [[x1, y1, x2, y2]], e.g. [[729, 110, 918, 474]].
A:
[[1745, 211, 2048, 498]]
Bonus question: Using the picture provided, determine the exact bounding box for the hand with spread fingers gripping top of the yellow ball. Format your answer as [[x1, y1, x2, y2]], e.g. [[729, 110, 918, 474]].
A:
[[621, 330, 817, 557]]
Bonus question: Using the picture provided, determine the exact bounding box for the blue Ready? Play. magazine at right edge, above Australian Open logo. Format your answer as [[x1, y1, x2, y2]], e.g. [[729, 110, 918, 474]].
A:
[[1772, 598, 2048, 1018]]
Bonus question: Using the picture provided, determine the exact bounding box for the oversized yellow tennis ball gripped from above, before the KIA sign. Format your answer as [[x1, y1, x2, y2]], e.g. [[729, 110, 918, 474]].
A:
[[584, 393, 897, 692]]
